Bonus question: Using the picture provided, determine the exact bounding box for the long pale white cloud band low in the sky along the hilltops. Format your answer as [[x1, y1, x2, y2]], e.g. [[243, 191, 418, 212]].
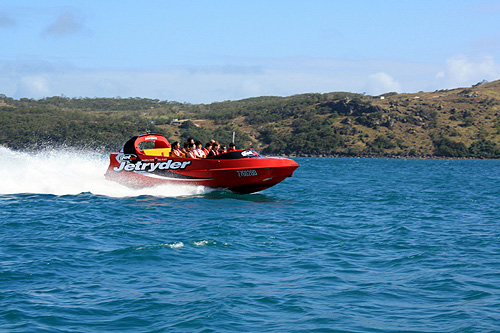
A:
[[0, 57, 500, 103]]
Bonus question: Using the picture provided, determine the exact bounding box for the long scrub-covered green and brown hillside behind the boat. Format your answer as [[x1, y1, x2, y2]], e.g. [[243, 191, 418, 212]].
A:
[[0, 81, 500, 158]]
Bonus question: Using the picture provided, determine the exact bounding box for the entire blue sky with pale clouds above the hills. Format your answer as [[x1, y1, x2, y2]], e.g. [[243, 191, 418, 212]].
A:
[[0, 0, 500, 104]]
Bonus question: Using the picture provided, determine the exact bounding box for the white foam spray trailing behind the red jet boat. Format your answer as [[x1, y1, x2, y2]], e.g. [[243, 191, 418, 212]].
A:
[[0, 147, 210, 197]]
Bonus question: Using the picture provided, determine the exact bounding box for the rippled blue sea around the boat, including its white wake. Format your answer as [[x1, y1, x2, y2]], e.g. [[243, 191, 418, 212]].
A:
[[0, 148, 500, 332]]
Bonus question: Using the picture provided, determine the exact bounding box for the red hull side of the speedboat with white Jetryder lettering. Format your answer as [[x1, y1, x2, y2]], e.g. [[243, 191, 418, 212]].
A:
[[106, 153, 299, 193]]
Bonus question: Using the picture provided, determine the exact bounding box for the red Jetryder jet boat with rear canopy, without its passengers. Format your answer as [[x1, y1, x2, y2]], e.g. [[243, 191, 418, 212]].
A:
[[105, 133, 300, 193]]
